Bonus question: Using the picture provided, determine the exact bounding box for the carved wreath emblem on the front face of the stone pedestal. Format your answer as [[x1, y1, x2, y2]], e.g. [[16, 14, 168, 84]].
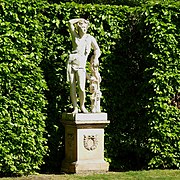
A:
[[84, 135, 98, 151]]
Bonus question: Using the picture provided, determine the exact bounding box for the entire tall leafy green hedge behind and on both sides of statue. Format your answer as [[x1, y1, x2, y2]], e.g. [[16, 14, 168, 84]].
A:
[[0, 0, 180, 174]]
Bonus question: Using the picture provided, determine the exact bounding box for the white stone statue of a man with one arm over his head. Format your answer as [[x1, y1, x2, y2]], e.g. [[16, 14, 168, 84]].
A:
[[67, 18, 101, 113]]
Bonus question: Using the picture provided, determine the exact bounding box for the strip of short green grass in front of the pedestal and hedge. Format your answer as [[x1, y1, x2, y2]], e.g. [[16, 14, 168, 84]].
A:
[[1, 170, 180, 180]]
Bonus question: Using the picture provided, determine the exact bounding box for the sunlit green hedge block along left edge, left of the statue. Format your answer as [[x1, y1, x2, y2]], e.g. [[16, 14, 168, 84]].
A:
[[0, 1, 47, 175]]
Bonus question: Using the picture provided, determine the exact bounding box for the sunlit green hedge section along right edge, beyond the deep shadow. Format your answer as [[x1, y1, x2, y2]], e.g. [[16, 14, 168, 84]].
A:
[[144, 3, 180, 168]]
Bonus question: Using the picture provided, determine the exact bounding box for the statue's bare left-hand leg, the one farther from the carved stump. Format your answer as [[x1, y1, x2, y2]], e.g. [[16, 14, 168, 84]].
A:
[[69, 69, 78, 113]]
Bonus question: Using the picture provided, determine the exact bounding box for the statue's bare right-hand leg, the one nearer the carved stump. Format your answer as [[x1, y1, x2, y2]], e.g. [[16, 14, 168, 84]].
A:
[[77, 69, 88, 113]]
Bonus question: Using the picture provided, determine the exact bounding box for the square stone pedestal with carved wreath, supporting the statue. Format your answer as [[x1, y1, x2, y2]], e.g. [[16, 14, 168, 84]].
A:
[[61, 113, 109, 173]]
